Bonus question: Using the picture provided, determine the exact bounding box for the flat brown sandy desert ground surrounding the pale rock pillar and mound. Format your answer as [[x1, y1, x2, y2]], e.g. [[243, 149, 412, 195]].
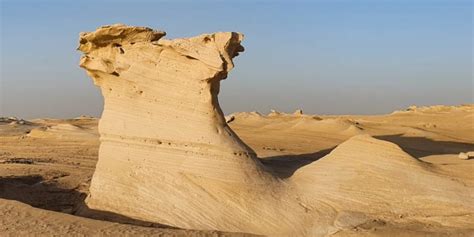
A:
[[0, 105, 474, 236]]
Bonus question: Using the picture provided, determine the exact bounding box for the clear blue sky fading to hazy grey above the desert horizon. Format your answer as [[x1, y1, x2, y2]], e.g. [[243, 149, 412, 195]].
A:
[[0, 0, 474, 118]]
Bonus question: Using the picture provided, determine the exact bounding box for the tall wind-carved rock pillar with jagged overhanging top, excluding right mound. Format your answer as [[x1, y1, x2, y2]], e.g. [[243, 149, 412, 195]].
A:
[[79, 25, 306, 233]]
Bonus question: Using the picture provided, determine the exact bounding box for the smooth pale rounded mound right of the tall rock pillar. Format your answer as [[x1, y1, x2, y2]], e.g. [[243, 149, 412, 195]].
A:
[[291, 135, 474, 218]]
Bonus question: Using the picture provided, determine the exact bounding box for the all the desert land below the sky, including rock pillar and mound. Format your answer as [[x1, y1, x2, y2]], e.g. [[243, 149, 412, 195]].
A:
[[0, 25, 474, 236]]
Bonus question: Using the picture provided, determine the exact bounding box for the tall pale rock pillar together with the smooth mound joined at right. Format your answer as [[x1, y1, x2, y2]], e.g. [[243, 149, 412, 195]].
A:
[[79, 25, 474, 236]]
